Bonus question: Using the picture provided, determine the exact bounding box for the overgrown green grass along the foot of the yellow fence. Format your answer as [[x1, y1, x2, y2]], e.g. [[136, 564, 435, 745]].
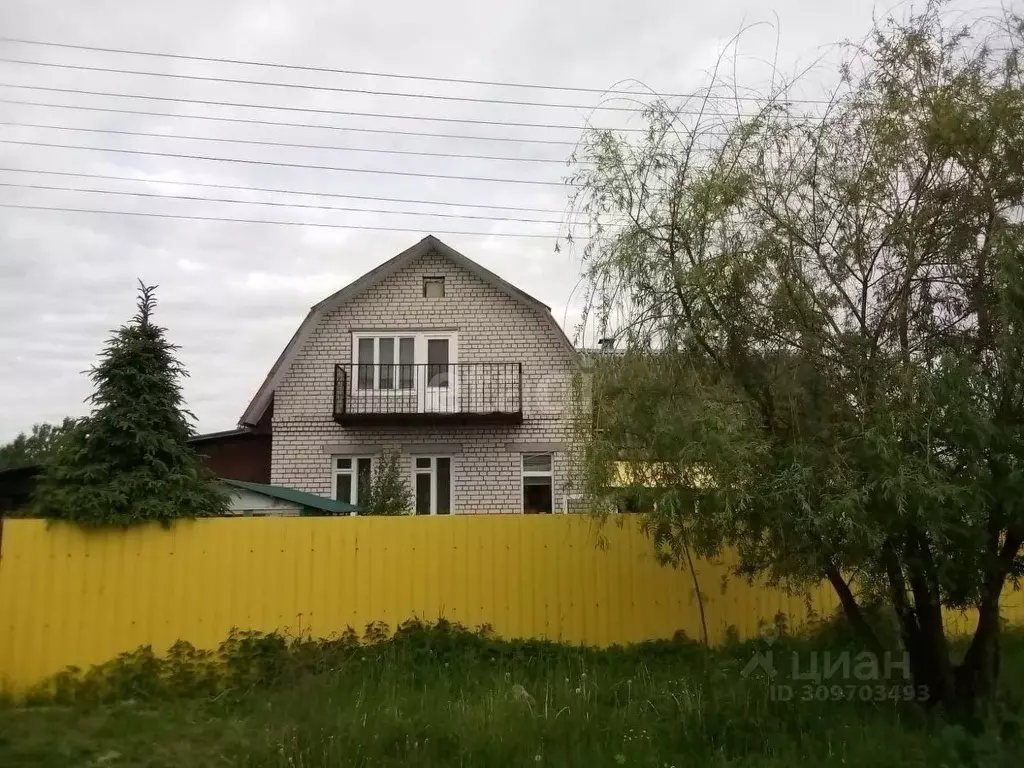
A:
[[0, 627, 1024, 768]]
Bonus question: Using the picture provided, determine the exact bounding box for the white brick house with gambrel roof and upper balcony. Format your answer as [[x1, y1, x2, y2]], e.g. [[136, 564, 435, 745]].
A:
[[241, 237, 574, 514]]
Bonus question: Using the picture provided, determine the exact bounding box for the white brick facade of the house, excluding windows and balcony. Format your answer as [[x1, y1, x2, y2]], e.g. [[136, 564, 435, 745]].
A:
[[271, 254, 572, 513]]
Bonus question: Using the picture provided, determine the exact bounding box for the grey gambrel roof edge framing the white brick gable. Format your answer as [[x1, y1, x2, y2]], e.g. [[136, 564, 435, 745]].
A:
[[239, 234, 574, 426]]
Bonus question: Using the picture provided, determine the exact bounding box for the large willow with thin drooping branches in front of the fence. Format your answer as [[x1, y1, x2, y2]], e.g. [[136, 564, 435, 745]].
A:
[[575, 7, 1024, 709]]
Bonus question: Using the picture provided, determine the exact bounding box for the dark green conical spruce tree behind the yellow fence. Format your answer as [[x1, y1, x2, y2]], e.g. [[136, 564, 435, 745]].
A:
[[36, 281, 227, 525]]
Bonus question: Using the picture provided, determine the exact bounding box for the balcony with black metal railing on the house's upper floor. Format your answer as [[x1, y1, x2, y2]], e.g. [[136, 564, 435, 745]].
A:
[[334, 362, 522, 426]]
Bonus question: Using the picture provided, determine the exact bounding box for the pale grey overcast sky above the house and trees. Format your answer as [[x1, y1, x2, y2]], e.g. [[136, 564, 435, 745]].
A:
[[0, 0, 978, 440]]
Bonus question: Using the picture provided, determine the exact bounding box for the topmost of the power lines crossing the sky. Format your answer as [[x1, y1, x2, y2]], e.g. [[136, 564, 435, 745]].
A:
[[0, 37, 826, 103]]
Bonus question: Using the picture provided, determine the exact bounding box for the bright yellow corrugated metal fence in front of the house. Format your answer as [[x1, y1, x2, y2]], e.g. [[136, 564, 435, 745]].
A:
[[0, 515, 1024, 691]]
